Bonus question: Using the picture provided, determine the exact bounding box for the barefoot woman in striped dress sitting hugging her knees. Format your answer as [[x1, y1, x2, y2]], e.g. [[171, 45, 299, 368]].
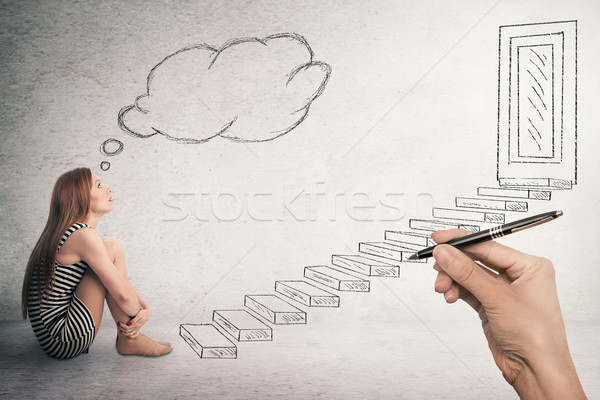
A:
[[22, 168, 171, 358]]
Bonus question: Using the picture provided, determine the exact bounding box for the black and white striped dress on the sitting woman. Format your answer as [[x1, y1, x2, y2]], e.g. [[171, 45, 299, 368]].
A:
[[28, 223, 94, 358]]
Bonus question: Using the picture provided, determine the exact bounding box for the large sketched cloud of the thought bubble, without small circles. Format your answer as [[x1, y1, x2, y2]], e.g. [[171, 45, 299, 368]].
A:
[[118, 33, 331, 143]]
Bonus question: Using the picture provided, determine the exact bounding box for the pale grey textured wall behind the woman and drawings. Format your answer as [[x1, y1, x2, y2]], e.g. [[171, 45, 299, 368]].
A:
[[0, 1, 600, 324]]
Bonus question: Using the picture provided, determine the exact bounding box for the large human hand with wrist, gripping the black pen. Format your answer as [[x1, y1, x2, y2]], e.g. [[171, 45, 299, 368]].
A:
[[432, 229, 586, 399]]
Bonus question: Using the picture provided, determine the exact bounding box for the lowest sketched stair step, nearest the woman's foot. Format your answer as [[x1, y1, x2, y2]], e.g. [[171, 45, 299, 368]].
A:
[[179, 324, 237, 358]]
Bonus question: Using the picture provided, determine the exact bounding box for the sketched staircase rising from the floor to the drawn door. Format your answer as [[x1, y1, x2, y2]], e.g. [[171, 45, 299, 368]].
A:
[[179, 183, 564, 359]]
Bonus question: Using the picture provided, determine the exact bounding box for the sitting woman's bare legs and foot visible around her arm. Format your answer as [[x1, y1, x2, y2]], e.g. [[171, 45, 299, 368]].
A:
[[75, 239, 171, 356]]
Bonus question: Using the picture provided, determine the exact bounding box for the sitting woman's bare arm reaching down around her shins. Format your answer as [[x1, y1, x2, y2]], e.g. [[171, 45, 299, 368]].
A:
[[70, 229, 142, 316]]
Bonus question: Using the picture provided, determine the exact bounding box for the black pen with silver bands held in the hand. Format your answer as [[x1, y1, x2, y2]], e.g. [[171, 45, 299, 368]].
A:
[[408, 211, 563, 260]]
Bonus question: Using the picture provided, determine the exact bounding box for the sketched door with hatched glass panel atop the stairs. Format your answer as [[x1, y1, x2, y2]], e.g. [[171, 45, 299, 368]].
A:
[[498, 21, 577, 188]]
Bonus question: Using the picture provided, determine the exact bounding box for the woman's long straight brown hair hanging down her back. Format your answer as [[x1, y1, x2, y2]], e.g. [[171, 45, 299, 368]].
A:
[[21, 168, 92, 319]]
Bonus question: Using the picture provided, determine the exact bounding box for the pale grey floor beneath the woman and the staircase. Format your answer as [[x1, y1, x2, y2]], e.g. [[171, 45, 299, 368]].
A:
[[0, 315, 600, 399]]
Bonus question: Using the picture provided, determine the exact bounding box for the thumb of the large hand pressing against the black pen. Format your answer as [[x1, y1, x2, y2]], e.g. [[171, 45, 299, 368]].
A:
[[433, 244, 497, 304]]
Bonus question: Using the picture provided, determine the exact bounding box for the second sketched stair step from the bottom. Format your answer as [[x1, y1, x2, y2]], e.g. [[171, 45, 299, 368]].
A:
[[213, 310, 273, 342]]
